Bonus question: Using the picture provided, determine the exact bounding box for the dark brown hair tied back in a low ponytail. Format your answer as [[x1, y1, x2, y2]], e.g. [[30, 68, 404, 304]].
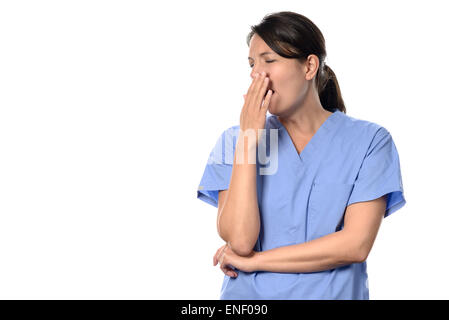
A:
[[246, 11, 346, 113]]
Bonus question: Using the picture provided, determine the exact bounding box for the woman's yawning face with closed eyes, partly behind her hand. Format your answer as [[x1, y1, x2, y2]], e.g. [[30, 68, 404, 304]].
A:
[[248, 34, 318, 116]]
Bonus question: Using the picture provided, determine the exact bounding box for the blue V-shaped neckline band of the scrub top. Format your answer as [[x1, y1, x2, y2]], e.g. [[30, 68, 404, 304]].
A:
[[273, 110, 342, 165]]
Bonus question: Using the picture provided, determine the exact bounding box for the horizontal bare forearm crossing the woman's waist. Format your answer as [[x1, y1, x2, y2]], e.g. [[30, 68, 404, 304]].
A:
[[253, 230, 363, 272]]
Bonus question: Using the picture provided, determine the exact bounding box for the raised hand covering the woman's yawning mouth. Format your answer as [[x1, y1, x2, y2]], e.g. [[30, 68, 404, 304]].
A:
[[240, 72, 273, 135]]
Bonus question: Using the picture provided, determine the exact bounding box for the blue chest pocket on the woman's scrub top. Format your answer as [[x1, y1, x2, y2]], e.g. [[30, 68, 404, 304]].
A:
[[307, 182, 354, 241]]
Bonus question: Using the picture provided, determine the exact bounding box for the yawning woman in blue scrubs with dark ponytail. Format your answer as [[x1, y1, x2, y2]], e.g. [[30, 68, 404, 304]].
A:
[[197, 12, 405, 300]]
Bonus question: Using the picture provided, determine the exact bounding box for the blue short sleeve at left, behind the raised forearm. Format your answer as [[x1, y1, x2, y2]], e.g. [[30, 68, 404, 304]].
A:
[[197, 126, 238, 208]]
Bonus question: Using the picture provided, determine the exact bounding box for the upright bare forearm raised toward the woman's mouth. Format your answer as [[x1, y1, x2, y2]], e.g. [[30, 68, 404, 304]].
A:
[[218, 135, 260, 255]]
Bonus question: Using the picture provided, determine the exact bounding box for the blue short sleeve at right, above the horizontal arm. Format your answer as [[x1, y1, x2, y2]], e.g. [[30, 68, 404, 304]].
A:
[[347, 127, 406, 218]]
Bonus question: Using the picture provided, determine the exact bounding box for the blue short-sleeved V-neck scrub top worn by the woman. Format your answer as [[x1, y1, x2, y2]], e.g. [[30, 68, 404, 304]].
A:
[[197, 110, 406, 300]]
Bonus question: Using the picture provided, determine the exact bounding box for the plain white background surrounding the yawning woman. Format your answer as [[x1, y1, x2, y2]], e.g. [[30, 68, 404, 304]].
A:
[[0, 0, 449, 299]]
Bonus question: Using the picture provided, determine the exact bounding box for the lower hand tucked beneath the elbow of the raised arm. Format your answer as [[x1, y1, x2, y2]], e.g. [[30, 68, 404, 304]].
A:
[[214, 243, 256, 277]]
